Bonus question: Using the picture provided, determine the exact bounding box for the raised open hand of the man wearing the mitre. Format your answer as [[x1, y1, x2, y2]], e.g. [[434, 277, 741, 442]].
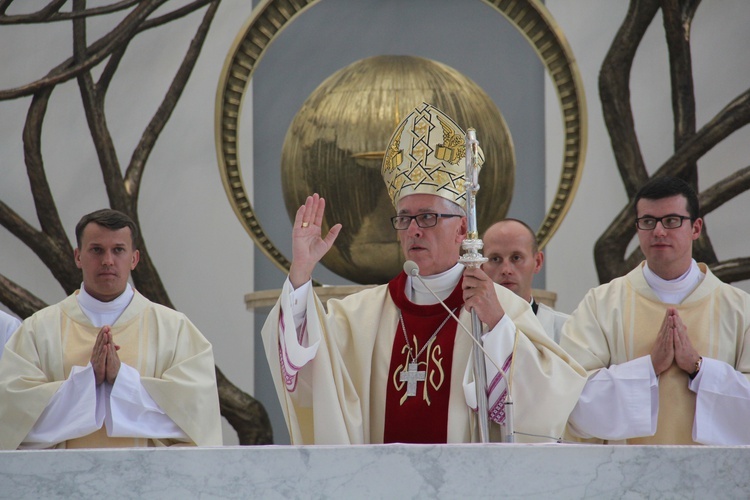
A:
[[289, 193, 341, 288]]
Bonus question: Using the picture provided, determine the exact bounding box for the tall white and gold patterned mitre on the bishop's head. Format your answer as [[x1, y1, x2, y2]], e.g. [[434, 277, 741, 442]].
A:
[[382, 103, 484, 208]]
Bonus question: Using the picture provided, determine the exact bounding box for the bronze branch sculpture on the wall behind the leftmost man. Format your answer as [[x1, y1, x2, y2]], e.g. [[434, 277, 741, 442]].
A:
[[0, 0, 273, 445]]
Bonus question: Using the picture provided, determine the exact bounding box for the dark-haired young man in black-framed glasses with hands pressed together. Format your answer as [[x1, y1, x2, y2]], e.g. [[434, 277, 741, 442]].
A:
[[560, 177, 750, 445]]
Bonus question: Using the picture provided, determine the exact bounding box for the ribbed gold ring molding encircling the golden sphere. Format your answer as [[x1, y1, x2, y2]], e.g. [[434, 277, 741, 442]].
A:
[[215, 0, 587, 272]]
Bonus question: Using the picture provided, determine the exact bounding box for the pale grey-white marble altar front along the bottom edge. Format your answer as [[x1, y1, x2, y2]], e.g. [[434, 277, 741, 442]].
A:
[[0, 444, 750, 499]]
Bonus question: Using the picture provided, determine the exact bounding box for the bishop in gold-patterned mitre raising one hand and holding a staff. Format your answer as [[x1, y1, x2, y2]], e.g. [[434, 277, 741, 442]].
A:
[[263, 104, 585, 444]]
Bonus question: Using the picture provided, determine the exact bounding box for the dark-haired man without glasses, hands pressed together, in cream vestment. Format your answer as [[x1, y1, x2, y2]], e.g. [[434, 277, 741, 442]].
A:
[[0, 209, 222, 450]]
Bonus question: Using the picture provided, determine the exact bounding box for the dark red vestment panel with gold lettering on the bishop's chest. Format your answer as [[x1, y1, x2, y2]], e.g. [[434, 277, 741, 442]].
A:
[[383, 272, 463, 443]]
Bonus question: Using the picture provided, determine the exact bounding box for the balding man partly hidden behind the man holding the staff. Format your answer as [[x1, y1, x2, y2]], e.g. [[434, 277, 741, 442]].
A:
[[482, 219, 568, 343]]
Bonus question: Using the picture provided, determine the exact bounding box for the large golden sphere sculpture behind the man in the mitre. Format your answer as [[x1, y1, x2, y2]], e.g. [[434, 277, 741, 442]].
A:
[[281, 56, 515, 284]]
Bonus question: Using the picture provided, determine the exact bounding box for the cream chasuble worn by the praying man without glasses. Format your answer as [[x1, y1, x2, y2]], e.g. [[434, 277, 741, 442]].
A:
[[0, 292, 222, 449]]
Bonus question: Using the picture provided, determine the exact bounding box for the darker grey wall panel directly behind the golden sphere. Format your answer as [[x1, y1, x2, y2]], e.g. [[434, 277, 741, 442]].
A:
[[251, 0, 545, 443]]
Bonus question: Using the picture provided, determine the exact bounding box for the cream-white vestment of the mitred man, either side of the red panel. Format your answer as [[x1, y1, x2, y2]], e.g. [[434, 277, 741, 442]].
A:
[[263, 265, 585, 444]]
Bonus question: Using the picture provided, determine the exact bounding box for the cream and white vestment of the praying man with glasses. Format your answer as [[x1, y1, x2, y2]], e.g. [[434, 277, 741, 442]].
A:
[[561, 264, 750, 445]]
